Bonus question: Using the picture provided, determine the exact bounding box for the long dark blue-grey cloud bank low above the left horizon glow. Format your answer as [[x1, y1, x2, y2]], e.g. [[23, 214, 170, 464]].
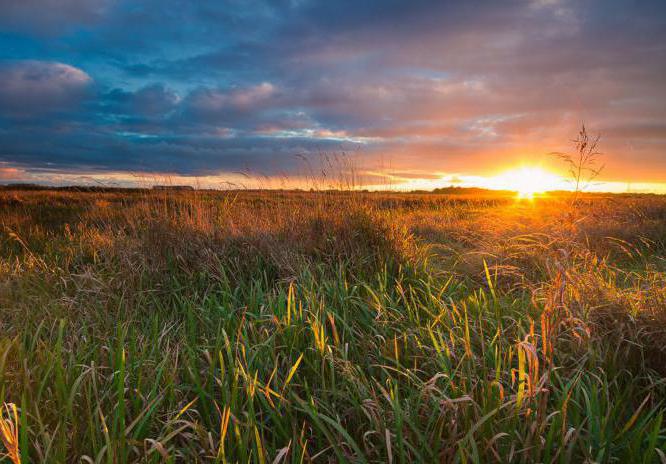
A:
[[0, 123, 350, 175]]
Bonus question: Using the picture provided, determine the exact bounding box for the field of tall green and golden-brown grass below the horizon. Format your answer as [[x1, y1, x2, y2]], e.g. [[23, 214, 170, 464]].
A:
[[0, 190, 666, 464]]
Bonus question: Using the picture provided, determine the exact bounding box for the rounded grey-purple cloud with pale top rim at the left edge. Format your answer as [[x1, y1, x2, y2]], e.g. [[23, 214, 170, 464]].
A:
[[0, 61, 92, 117]]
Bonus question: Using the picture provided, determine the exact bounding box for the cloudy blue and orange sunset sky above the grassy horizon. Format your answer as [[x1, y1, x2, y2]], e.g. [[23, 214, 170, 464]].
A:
[[0, 0, 666, 192]]
